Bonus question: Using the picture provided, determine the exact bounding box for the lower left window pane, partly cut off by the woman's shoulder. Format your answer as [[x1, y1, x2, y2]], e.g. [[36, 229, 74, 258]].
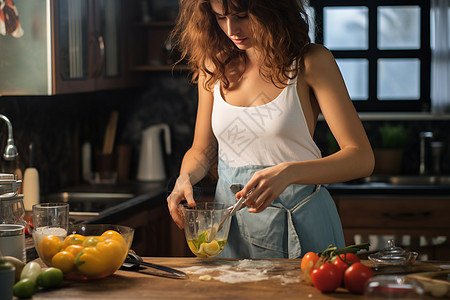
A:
[[336, 59, 369, 100]]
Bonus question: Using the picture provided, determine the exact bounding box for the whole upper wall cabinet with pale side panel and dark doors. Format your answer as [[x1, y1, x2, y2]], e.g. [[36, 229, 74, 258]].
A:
[[0, 0, 135, 95]]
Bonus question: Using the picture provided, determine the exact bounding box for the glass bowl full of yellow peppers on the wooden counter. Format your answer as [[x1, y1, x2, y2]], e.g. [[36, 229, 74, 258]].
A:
[[34, 224, 134, 280]]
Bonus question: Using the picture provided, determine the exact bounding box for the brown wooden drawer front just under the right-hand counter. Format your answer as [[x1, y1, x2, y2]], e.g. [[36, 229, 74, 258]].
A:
[[335, 197, 450, 231]]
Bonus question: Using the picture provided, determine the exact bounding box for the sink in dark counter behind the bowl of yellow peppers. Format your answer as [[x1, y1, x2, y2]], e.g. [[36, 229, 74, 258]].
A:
[[41, 192, 135, 223]]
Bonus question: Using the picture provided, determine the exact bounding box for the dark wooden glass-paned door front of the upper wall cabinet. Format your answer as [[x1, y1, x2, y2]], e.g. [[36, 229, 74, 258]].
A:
[[52, 0, 128, 94]]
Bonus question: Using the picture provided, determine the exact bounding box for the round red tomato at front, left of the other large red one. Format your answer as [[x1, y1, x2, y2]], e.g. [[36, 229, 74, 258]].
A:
[[311, 262, 342, 293]]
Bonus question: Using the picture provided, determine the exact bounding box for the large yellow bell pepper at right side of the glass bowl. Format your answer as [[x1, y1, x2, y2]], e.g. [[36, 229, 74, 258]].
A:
[[75, 239, 127, 278]]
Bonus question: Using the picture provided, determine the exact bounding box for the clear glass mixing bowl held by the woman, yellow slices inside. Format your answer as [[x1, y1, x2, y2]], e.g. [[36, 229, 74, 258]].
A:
[[180, 202, 231, 257]]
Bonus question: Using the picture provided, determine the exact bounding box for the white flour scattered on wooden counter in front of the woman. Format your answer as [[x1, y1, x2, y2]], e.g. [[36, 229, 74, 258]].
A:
[[178, 259, 300, 285]]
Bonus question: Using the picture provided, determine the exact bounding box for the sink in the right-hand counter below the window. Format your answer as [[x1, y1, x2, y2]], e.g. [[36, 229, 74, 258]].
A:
[[363, 175, 450, 185]]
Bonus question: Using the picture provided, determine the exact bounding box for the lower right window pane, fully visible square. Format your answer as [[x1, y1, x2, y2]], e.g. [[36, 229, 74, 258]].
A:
[[377, 58, 420, 100]]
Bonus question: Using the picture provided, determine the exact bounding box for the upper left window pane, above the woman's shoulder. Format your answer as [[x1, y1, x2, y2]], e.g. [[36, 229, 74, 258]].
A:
[[323, 6, 369, 50]]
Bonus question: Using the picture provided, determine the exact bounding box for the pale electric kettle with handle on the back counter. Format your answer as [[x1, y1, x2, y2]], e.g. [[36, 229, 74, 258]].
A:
[[137, 124, 172, 181]]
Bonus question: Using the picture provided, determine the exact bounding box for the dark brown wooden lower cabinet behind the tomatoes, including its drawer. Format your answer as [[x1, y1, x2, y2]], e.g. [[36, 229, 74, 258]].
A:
[[333, 195, 450, 260]]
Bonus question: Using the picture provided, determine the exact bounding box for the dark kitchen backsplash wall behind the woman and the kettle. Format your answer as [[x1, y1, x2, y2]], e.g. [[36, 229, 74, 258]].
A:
[[0, 73, 450, 194]]
